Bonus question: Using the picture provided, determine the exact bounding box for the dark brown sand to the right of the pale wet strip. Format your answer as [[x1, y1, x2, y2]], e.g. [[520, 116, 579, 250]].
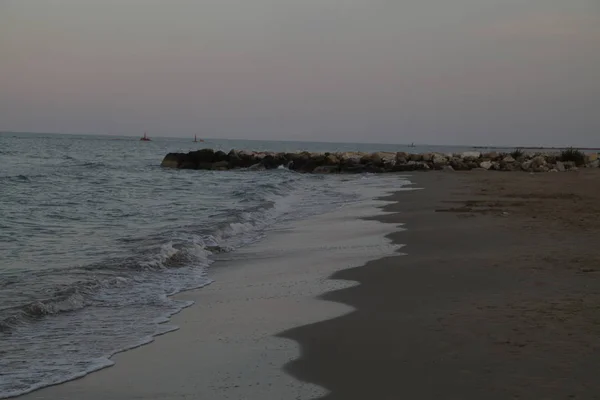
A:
[[280, 170, 600, 400]]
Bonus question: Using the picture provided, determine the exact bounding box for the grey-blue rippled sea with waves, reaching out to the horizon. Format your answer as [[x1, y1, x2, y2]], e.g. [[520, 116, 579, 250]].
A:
[[0, 132, 482, 398]]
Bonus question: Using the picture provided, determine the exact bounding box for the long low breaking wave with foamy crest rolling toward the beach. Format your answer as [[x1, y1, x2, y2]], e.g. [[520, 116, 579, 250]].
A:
[[0, 185, 293, 332]]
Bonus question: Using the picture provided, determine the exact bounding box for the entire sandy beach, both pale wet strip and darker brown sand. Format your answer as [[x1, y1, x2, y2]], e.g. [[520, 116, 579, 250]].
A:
[[17, 170, 600, 400]]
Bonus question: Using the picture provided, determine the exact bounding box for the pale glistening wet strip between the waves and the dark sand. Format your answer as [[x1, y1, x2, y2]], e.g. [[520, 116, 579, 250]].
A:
[[18, 176, 402, 400]]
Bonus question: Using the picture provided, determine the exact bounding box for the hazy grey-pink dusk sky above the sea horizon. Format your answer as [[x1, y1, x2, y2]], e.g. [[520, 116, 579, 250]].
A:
[[0, 0, 600, 146]]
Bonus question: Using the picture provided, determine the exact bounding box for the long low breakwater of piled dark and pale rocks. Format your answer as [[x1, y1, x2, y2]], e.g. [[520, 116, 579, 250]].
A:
[[161, 149, 599, 173]]
